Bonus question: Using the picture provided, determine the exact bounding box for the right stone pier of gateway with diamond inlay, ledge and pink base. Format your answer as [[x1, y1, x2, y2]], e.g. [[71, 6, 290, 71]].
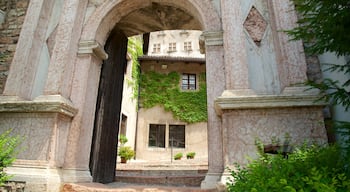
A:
[[215, 0, 327, 187]]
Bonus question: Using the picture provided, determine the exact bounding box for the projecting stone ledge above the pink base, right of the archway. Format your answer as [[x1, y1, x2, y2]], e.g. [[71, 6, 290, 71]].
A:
[[215, 87, 326, 115]]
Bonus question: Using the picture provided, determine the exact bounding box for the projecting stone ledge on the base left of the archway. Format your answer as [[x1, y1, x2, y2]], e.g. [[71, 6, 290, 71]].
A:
[[0, 95, 78, 117]]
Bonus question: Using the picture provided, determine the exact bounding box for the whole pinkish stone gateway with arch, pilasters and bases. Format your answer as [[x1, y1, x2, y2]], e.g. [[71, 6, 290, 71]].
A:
[[0, 0, 327, 191]]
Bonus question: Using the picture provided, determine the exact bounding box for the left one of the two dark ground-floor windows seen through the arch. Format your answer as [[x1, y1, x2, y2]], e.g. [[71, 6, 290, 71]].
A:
[[148, 124, 165, 148]]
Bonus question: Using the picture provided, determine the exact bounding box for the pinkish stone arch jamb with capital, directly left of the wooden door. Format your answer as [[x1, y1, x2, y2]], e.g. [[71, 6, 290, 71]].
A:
[[64, 40, 107, 174]]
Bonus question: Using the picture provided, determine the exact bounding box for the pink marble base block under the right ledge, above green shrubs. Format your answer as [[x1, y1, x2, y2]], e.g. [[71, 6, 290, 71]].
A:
[[222, 107, 327, 165]]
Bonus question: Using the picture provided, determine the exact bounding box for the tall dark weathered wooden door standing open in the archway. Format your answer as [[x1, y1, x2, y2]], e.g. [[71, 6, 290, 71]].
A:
[[90, 28, 128, 183]]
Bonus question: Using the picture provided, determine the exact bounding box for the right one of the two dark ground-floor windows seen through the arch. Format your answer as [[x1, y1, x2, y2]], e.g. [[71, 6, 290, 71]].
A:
[[169, 125, 185, 148]]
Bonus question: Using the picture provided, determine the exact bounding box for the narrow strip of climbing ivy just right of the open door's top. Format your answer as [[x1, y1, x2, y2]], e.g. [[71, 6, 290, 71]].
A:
[[128, 36, 143, 98]]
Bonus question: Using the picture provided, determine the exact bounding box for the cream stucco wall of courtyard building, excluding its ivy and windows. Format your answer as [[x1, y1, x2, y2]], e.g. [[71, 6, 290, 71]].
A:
[[136, 54, 208, 163]]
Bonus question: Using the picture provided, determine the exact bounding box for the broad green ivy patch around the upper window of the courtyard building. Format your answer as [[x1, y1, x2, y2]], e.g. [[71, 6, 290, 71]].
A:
[[140, 71, 207, 123]]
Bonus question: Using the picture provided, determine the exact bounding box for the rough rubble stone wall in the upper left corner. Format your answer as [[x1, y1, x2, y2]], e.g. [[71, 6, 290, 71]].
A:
[[0, 0, 29, 93]]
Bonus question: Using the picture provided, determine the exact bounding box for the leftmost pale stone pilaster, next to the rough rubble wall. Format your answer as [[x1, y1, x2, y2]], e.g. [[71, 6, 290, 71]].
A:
[[3, 0, 55, 100]]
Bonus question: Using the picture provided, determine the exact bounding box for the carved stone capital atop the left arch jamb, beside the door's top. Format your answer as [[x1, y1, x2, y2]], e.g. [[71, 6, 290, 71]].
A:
[[78, 40, 108, 60]]
